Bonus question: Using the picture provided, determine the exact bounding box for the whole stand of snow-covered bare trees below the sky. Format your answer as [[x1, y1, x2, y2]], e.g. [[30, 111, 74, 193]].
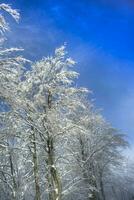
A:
[[0, 4, 134, 200]]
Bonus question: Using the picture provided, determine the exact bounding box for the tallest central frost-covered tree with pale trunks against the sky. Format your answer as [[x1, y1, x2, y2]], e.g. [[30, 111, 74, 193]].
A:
[[19, 46, 87, 200]]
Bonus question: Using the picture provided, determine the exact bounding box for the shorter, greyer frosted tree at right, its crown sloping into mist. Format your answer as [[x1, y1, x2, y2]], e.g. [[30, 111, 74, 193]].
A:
[[74, 111, 127, 200]]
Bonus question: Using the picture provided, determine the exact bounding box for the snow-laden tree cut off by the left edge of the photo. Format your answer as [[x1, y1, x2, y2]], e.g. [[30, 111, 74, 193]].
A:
[[0, 4, 26, 199]]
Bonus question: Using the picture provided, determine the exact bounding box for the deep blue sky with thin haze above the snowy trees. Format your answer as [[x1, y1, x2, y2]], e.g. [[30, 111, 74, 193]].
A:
[[3, 0, 134, 144]]
